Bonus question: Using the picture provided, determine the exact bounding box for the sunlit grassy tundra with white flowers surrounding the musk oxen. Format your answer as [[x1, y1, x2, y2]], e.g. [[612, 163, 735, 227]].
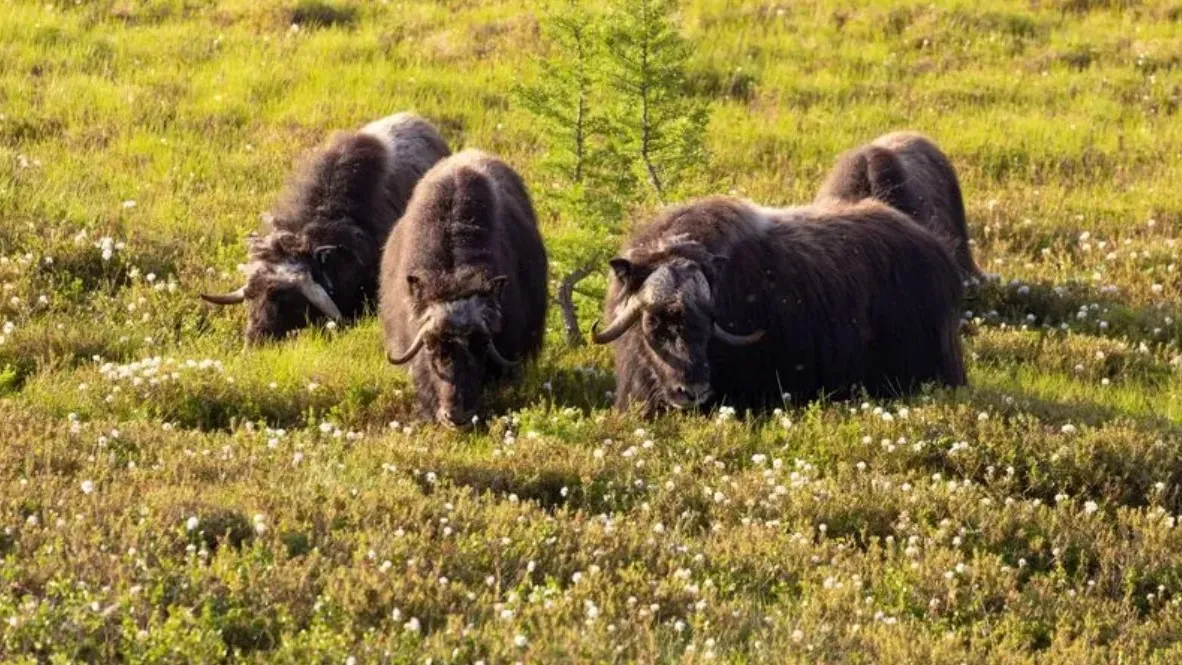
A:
[[0, 0, 1182, 665]]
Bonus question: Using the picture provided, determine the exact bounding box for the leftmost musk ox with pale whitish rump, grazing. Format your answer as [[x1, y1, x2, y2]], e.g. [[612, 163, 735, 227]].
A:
[[201, 113, 450, 343]]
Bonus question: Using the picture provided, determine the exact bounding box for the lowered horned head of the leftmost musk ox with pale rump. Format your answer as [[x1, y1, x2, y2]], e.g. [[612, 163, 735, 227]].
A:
[[201, 232, 359, 344]]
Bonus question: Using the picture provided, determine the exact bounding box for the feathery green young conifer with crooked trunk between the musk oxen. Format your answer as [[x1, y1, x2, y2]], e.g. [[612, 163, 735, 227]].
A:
[[517, 0, 709, 346]]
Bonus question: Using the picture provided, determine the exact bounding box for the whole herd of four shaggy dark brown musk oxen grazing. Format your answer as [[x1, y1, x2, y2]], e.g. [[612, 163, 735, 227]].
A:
[[202, 113, 982, 426]]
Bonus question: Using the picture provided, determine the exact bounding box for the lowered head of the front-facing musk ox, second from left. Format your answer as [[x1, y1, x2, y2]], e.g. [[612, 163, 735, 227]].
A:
[[388, 273, 517, 426]]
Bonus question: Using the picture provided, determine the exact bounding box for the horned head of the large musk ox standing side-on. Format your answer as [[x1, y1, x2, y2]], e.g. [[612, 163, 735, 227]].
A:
[[592, 242, 764, 409]]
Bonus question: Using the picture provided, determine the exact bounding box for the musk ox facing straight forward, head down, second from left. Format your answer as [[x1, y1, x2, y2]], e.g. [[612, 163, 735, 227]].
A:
[[379, 150, 547, 426]]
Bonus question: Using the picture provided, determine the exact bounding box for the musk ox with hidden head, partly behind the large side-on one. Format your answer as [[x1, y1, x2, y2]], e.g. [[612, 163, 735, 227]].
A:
[[816, 131, 985, 280]]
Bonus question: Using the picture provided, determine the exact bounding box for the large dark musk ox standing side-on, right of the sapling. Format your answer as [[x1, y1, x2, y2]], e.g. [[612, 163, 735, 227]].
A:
[[592, 197, 965, 413]]
